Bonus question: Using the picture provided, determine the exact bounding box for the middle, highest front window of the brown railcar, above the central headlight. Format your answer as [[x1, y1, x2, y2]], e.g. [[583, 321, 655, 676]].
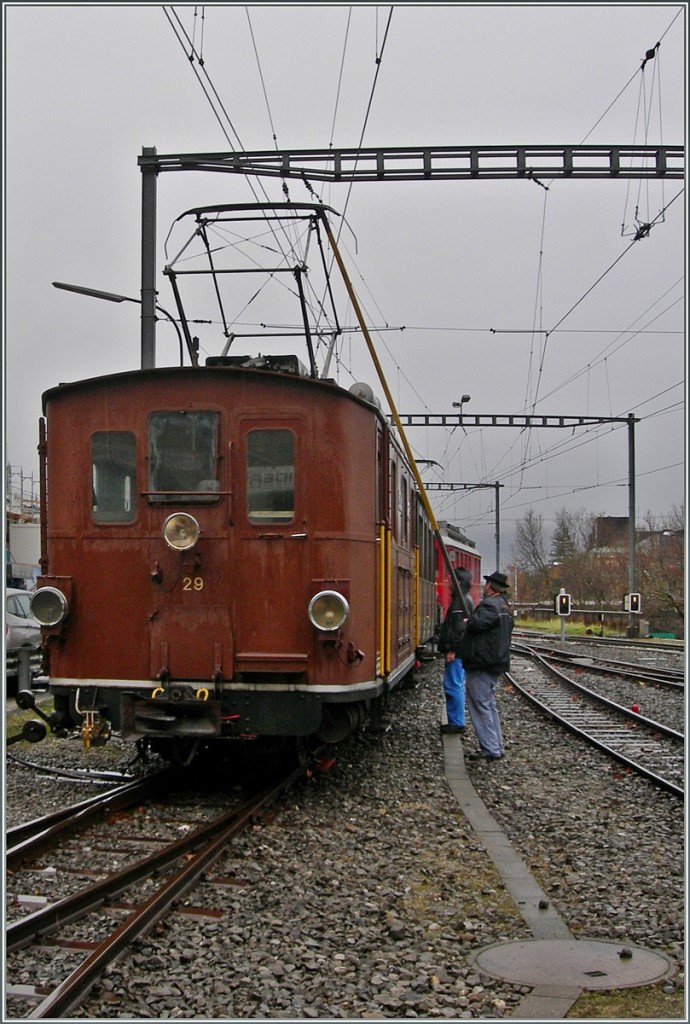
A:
[[148, 412, 219, 503]]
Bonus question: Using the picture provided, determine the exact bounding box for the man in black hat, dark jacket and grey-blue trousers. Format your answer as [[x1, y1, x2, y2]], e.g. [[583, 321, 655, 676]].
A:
[[461, 572, 514, 761]]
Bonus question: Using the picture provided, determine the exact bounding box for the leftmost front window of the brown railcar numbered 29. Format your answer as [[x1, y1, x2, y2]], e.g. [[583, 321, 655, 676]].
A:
[[91, 430, 136, 522]]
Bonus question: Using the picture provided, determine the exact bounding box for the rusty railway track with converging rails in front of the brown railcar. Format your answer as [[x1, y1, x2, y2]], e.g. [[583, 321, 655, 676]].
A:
[[5, 765, 306, 1020]]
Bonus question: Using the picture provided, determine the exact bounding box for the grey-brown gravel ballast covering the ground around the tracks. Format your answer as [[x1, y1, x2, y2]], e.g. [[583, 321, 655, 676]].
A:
[[5, 643, 684, 1019]]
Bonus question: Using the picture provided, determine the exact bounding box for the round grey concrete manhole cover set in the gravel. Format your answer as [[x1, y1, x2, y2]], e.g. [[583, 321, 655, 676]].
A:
[[474, 939, 676, 989]]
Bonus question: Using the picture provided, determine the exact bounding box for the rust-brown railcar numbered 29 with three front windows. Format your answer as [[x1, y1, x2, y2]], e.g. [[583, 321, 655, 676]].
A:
[[33, 356, 435, 760]]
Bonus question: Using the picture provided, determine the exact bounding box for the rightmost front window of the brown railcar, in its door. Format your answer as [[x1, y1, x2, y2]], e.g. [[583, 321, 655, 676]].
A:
[[247, 430, 295, 524]]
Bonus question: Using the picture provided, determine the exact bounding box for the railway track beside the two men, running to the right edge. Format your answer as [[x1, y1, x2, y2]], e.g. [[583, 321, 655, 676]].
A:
[[508, 643, 685, 797]]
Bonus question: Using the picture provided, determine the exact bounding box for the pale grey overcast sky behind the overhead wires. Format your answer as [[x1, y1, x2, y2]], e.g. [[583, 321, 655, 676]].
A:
[[3, 3, 687, 570]]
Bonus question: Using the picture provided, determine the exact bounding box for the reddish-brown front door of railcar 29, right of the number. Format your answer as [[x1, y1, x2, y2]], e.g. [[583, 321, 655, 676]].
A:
[[233, 419, 310, 673]]
